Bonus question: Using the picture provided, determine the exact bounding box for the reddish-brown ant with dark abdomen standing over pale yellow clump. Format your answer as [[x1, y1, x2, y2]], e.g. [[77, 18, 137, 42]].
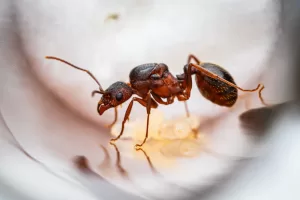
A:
[[46, 54, 266, 150]]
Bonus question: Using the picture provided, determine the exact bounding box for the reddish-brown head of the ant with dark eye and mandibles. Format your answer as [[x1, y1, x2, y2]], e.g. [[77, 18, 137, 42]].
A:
[[92, 81, 133, 115]]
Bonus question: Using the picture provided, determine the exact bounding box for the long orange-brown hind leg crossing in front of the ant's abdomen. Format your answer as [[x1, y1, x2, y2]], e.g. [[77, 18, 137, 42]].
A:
[[187, 63, 265, 105]]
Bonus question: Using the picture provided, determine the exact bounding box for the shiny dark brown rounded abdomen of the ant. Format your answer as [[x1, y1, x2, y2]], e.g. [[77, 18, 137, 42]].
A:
[[195, 63, 238, 107]]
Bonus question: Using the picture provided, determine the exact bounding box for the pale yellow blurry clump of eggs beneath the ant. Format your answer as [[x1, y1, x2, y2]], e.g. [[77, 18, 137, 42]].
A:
[[111, 110, 205, 168]]
